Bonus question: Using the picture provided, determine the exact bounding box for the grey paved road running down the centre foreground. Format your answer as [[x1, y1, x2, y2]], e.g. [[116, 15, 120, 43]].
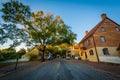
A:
[[0, 59, 119, 80]]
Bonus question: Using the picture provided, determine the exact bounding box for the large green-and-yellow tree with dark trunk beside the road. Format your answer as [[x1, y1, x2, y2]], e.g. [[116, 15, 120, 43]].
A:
[[24, 11, 76, 61]]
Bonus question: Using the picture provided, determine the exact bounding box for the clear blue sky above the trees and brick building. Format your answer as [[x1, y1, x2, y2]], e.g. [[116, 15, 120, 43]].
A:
[[0, 0, 120, 49]]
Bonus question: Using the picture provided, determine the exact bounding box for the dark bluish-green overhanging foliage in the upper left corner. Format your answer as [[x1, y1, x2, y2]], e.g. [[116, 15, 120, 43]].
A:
[[0, 0, 31, 47]]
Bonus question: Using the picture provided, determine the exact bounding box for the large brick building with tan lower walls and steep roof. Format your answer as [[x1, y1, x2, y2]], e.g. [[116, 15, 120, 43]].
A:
[[79, 14, 120, 63]]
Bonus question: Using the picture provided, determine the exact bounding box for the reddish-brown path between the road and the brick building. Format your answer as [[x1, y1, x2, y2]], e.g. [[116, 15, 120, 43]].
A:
[[71, 60, 120, 77]]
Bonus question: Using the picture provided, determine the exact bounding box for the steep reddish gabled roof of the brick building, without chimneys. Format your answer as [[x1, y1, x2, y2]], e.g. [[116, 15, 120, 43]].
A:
[[79, 17, 120, 43]]
